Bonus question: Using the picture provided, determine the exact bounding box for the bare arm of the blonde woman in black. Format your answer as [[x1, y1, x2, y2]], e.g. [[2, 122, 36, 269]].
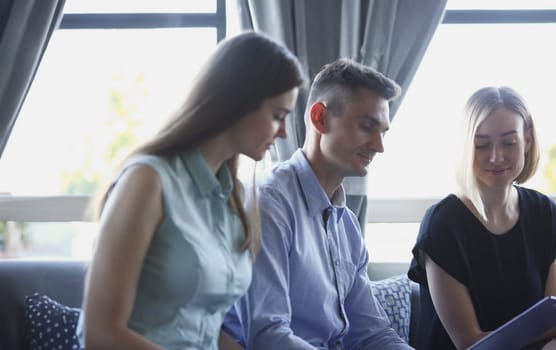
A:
[[423, 253, 488, 349]]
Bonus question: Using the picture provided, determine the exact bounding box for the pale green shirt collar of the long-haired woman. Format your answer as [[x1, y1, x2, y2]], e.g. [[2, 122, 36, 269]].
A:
[[181, 149, 233, 199]]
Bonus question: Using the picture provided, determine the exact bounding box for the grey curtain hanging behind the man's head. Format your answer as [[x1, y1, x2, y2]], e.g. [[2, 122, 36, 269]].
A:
[[238, 0, 447, 232]]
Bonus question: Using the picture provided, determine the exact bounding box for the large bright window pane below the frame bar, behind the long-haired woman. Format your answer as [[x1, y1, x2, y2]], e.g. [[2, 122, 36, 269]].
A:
[[0, 28, 216, 195]]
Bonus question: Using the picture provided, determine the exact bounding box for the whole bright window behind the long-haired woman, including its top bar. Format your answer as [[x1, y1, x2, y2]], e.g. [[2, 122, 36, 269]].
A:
[[0, 0, 227, 258]]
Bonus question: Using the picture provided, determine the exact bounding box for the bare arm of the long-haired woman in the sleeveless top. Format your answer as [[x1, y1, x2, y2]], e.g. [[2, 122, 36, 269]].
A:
[[84, 165, 163, 350]]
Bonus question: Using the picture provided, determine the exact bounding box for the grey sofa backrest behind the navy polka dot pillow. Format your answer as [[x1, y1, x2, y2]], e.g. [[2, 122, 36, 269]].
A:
[[0, 260, 87, 349]]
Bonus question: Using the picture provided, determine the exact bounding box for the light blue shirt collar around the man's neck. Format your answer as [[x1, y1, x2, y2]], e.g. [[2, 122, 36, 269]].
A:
[[291, 149, 346, 221]]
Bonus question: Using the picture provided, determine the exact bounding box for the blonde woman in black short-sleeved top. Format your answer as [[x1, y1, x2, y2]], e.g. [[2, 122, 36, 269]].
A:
[[409, 87, 556, 350]]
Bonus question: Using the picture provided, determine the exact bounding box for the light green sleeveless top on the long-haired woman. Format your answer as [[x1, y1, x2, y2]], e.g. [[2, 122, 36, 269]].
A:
[[78, 150, 252, 350]]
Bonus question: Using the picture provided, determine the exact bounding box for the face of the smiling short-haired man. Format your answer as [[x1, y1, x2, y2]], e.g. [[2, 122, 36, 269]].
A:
[[320, 88, 390, 177]]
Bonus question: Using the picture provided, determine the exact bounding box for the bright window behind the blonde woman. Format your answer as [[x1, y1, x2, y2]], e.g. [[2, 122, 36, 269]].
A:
[[366, 0, 556, 262]]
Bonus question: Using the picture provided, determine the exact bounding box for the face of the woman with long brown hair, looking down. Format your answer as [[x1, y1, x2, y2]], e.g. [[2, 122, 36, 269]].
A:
[[233, 88, 298, 160]]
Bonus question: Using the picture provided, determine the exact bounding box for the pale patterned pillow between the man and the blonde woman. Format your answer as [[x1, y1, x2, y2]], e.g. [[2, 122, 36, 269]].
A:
[[371, 275, 411, 342]]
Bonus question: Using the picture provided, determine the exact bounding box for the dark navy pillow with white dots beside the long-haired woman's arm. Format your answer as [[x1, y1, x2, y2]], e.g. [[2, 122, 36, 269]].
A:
[[25, 293, 80, 350]]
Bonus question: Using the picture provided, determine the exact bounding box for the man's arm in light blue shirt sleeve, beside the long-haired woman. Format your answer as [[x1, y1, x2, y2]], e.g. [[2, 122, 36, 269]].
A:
[[247, 192, 316, 350]]
